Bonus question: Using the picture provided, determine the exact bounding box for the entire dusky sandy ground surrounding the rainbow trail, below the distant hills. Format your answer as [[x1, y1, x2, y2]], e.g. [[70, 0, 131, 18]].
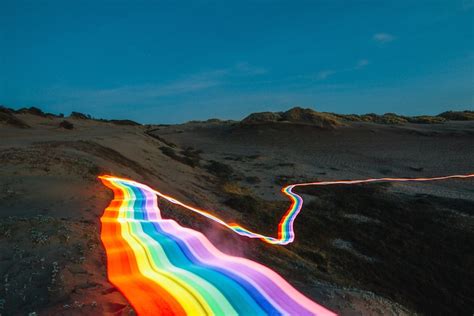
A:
[[0, 108, 474, 315]]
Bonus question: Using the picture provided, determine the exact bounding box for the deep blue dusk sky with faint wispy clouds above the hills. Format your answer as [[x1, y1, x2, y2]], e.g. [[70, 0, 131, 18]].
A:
[[0, 0, 474, 123]]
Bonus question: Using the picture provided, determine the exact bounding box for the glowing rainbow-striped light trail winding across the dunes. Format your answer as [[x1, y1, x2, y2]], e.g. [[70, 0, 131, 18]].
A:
[[100, 174, 474, 315]]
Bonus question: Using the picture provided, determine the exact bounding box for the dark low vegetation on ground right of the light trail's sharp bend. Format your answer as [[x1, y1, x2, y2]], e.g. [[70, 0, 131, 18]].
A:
[[289, 183, 474, 315]]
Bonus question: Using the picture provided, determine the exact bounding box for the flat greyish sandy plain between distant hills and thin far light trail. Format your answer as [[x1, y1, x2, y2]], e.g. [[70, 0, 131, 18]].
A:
[[155, 122, 474, 198]]
